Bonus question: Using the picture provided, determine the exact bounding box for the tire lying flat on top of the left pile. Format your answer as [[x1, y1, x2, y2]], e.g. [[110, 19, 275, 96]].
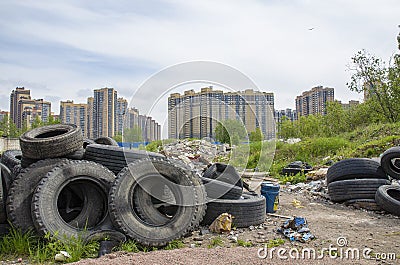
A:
[[19, 124, 83, 159]]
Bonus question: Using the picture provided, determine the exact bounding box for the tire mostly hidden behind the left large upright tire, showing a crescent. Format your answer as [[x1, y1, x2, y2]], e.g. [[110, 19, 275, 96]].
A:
[[7, 158, 68, 232]]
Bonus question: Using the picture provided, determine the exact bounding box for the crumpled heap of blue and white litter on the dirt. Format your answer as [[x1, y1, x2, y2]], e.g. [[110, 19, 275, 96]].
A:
[[278, 216, 315, 243]]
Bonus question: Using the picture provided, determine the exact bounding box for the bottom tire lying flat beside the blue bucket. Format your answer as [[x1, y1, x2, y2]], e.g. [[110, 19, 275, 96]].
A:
[[203, 193, 266, 227]]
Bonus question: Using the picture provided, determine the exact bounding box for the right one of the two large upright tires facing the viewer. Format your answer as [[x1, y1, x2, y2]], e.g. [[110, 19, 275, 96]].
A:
[[109, 158, 206, 246]]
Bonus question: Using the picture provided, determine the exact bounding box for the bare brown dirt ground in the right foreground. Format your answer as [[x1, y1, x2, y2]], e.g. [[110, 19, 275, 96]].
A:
[[71, 185, 400, 265]]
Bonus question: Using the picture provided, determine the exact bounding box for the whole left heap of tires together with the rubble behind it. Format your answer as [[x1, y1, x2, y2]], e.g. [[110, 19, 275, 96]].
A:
[[0, 124, 265, 251]]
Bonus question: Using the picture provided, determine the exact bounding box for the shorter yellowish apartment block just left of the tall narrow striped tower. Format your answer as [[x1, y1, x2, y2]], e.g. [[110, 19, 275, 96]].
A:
[[60, 100, 89, 137]]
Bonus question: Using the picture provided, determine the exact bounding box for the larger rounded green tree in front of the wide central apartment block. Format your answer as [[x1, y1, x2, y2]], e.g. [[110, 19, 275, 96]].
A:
[[215, 120, 247, 145]]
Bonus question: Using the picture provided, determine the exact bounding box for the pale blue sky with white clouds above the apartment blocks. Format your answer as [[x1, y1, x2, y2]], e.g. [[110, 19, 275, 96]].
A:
[[0, 0, 400, 127]]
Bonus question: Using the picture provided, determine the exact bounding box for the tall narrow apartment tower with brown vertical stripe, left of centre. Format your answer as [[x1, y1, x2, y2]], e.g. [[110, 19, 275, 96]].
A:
[[93, 87, 118, 138]]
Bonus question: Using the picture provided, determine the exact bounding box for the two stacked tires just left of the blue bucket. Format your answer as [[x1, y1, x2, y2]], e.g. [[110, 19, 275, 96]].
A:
[[201, 163, 266, 227]]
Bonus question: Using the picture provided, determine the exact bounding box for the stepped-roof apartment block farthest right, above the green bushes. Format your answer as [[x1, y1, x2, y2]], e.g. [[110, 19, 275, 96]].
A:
[[296, 86, 335, 117]]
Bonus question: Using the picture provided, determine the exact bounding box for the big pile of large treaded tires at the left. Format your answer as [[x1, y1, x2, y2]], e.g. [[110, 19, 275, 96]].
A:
[[0, 124, 206, 246]]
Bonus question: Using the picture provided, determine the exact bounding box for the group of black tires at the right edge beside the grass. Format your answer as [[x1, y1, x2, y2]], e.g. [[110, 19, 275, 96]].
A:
[[326, 150, 400, 215]]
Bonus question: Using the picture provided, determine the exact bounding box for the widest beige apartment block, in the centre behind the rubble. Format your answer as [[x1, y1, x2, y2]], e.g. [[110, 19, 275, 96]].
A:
[[168, 87, 275, 139]]
